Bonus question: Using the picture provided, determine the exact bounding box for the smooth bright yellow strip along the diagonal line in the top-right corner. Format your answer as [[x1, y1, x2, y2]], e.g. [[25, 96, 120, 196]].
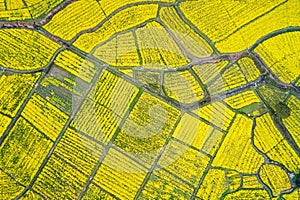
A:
[[216, 0, 300, 52]]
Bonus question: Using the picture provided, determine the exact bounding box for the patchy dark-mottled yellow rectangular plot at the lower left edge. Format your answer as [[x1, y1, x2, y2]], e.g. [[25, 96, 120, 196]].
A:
[[0, 118, 52, 185]]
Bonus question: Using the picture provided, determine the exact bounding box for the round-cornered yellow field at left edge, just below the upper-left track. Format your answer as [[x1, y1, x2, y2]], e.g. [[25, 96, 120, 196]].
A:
[[0, 29, 60, 70]]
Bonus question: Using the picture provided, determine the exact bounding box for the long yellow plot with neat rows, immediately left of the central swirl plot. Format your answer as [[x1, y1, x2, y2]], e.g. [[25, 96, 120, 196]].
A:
[[71, 70, 139, 143]]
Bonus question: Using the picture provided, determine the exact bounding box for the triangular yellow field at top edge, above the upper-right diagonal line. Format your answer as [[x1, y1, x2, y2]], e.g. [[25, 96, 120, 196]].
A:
[[180, 0, 283, 49]]
